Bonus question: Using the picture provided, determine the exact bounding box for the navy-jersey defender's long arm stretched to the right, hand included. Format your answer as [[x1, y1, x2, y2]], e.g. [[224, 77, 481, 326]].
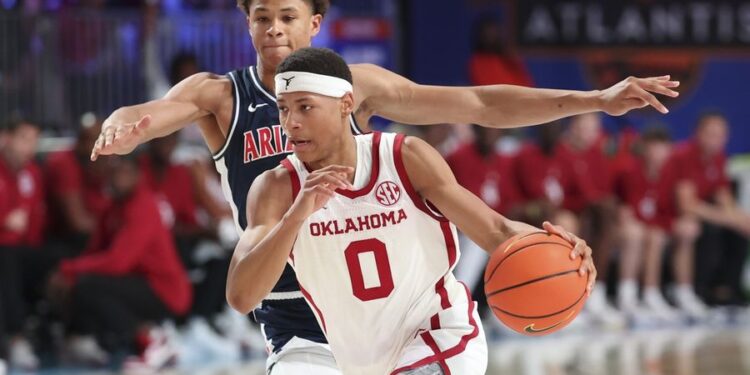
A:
[[351, 64, 679, 128]]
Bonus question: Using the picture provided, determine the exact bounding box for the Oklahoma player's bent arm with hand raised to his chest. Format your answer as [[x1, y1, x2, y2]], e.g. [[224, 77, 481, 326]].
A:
[[226, 165, 354, 314]]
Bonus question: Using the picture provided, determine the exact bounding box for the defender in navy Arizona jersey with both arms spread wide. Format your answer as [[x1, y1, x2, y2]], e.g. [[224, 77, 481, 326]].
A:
[[91, 0, 679, 374]]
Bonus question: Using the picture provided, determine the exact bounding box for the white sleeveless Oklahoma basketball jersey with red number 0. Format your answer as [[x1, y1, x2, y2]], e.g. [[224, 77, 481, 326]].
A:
[[282, 133, 477, 375]]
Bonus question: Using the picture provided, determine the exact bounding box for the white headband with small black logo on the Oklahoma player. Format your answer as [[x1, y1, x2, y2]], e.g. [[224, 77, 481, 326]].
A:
[[275, 72, 354, 98]]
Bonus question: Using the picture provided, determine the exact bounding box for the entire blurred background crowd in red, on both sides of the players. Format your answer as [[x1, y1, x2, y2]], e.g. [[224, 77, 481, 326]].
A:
[[0, 5, 750, 370]]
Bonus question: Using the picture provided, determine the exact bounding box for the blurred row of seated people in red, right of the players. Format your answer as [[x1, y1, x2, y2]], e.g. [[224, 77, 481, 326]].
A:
[[423, 112, 750, 334]]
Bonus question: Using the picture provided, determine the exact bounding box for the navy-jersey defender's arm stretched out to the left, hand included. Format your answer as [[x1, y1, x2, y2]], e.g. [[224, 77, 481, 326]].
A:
[[91, 73, 232, 160]]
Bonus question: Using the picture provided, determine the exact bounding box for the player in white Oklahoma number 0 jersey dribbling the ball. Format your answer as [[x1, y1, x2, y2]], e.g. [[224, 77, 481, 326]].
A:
[[227, 48, 596, 375]]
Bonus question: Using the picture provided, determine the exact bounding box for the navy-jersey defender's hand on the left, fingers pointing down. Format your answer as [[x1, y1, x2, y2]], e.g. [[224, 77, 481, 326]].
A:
[[91, 114, 151, 161]]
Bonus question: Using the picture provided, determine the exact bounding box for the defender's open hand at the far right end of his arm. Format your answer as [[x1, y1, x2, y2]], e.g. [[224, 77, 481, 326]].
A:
[[599, 75, 680, 116]]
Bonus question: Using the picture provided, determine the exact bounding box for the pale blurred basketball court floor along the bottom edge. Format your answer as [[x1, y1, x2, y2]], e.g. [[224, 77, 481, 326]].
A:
[[23, 311, 750, 375]]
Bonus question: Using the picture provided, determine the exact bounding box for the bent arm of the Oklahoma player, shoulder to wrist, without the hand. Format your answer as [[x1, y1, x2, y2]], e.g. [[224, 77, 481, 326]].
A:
[[226, 168, 301, 314]]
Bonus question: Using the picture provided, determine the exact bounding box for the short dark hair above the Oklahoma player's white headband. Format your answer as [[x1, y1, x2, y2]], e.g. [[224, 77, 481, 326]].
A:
[[276, 47, 354, 83]]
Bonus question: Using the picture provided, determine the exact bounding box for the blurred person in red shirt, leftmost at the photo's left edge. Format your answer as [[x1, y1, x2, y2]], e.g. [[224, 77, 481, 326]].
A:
[[0, 120, 45, 370]]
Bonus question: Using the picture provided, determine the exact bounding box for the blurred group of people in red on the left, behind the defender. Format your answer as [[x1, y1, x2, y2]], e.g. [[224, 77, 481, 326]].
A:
[[0, 115, 268, 369]]
